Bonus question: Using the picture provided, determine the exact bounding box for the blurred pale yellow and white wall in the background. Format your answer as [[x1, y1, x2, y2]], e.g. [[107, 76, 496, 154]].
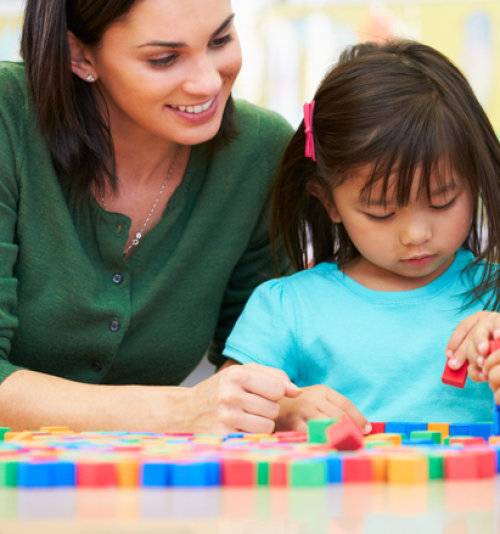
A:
[[0, 0, 500, 385]]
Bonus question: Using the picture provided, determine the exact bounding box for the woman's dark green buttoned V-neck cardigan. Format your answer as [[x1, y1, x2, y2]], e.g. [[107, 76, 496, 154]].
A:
[[0, 63, 291, 385]]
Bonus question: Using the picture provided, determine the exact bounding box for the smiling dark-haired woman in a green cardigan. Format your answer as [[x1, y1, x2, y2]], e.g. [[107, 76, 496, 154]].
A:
[[0, 0, 368, 433]]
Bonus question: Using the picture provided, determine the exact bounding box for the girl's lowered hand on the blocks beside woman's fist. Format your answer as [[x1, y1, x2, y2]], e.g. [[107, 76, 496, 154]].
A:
[[276, 385, 372, 434]]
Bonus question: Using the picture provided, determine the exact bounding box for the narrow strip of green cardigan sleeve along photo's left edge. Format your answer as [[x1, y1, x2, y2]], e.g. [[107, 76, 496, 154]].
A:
[[0, 70, 22, 382]]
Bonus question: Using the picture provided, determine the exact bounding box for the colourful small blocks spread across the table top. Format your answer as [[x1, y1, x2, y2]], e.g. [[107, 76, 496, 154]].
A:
[[0, 417, 500, 488]]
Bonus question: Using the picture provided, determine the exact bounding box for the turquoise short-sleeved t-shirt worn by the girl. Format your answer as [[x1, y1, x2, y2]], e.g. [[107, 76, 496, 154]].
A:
[[224, 250, 493, 423]]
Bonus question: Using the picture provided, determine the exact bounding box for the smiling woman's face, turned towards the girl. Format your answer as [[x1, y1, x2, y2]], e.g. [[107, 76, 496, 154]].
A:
[[91, 0, 241, 145]]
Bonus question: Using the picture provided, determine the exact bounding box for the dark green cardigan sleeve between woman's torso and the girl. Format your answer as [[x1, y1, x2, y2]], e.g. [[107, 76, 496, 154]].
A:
[[208, 111, 293, 368]]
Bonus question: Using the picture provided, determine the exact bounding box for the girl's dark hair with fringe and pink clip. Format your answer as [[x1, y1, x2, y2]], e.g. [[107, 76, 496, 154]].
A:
[[271, 40, 500, 309]]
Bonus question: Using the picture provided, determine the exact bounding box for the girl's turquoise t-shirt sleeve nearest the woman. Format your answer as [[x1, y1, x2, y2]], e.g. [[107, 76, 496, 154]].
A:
[[223, 279, 300, 381]]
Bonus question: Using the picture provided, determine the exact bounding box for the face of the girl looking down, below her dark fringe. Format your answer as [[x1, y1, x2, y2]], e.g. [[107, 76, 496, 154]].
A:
[[327, 165, 474, 291]]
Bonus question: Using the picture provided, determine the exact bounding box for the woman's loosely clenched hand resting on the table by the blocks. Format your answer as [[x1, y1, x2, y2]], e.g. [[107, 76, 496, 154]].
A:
[[180, 361, 301, 434]]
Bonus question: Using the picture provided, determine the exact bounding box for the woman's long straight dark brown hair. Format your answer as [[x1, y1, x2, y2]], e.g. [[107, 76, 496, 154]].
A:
[[21, 0, 236, 198]]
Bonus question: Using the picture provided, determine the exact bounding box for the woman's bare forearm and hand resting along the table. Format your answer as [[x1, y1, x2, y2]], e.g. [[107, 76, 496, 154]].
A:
[[0, 364, 300, 434]]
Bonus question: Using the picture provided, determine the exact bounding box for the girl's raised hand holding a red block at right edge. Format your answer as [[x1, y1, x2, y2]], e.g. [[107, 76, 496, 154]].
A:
[[446, 311, 500, 384]]
